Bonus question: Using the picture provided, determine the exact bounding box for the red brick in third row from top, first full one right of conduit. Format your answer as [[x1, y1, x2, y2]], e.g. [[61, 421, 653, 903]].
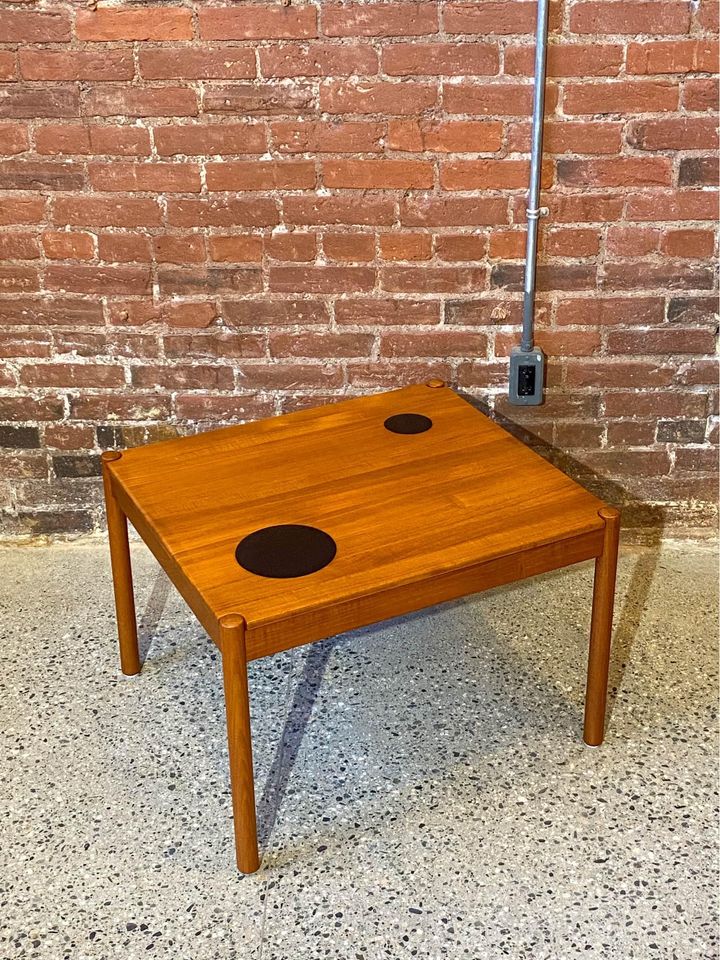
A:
[[563, 79, 680, 116]]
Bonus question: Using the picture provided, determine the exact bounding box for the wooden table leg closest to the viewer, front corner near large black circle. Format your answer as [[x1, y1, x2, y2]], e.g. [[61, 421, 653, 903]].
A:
[[220, 613, 260, 873]]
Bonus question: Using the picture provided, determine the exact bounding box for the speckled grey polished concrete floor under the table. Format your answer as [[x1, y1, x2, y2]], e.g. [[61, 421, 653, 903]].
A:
[[0, 541, 718, 960]]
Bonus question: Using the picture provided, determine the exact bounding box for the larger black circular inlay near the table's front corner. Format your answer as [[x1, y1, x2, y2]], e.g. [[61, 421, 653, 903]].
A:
[[235, 523, 337, 579]]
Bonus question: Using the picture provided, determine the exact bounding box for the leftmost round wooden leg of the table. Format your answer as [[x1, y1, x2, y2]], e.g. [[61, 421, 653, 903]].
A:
[[101, 450, 140, 675]]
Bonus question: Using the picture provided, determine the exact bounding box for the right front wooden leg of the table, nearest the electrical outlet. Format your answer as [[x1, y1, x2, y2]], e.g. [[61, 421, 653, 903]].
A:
[[583, 507, 620, 747]]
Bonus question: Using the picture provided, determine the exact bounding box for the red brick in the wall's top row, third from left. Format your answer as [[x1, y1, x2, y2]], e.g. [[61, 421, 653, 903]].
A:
[[198, 3, 317, 40]]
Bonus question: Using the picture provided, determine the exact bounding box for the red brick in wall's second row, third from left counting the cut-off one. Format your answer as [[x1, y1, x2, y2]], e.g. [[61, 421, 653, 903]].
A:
[[138, 46, 256, 80]]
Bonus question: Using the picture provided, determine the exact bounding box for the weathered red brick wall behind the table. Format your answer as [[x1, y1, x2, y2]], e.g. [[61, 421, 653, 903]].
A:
[[0, 0, 718, 535]]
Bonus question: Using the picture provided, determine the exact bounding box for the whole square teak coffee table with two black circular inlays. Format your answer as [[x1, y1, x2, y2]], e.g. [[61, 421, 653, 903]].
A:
[[102, 380, 619, 873]]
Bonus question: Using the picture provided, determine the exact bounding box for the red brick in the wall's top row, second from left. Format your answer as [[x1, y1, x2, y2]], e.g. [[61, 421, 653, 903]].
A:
[[75, 6, 192, 41]]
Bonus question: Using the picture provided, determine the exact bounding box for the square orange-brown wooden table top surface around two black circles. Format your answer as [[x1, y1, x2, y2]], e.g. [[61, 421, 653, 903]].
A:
[[110, 381, 604, 635]]
